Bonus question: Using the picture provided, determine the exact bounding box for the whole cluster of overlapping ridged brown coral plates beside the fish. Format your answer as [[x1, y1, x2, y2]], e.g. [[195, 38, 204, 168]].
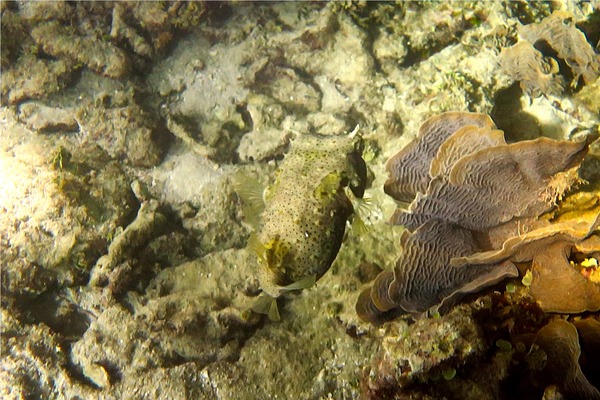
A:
[[356, 112, 600, 323]]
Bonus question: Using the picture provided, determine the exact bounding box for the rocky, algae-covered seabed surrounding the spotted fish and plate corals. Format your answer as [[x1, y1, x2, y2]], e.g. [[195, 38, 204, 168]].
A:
[[0, 1, 600, 400]]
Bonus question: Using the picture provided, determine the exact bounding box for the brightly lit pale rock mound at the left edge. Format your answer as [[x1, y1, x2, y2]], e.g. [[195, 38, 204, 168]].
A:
[[0, 111, 135, 296]]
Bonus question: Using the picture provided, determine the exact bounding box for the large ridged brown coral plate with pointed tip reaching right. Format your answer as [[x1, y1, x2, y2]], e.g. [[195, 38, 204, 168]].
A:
[[393, 138, 587, 230]]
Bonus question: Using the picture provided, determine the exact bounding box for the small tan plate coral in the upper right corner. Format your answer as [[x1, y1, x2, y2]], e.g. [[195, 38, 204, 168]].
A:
[[500, 10, 600, 97]]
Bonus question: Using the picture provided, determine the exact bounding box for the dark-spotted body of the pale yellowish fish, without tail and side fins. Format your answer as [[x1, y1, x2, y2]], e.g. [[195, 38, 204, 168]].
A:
[[254, 135, 366, 297]]
